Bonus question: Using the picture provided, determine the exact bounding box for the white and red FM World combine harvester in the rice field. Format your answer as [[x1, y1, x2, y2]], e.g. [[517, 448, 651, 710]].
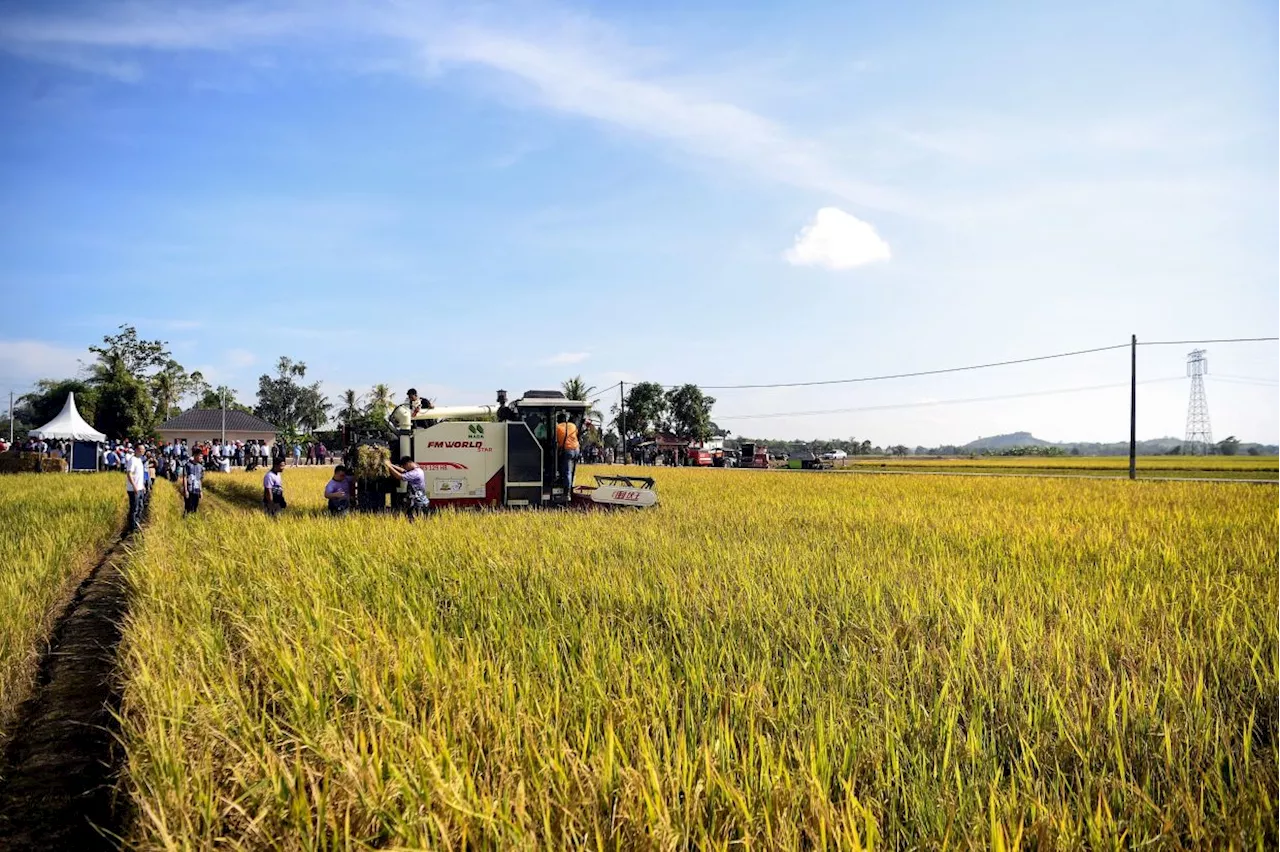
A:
[[357, 390, 658, 509]]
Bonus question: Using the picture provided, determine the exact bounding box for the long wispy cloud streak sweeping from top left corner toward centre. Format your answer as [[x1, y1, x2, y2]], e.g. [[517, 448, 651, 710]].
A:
[[0, 3, 914, 212]]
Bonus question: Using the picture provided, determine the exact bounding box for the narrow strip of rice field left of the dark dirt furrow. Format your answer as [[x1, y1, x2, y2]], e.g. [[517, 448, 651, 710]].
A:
[[0, 473, 125, 742]]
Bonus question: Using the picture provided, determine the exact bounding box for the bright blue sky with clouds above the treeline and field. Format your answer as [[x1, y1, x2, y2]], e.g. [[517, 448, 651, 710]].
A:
[[0, 0, 1280, 445]]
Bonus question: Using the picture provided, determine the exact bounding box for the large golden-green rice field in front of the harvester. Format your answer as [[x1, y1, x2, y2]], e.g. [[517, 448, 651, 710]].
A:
[[122, 468, 1280, 849]]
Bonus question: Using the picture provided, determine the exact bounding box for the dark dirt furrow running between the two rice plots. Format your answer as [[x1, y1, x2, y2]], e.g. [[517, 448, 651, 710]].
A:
[[0, 514, 137, 851]]
